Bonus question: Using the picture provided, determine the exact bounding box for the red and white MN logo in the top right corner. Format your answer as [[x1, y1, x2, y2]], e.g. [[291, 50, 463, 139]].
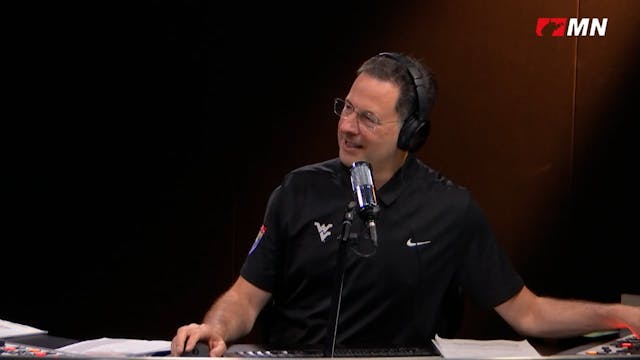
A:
[[536, 18, 609, 37]]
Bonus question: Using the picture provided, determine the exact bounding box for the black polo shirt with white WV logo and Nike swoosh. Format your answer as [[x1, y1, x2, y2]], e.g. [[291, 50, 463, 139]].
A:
[[241, 155, 523, 347]]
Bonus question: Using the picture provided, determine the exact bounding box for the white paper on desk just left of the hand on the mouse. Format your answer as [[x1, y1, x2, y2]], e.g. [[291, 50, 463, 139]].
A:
[[57, 337, 171, 356]]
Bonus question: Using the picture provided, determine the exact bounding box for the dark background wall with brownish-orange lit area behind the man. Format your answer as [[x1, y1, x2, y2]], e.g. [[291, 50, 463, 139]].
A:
[[5, 0, 640, 339]]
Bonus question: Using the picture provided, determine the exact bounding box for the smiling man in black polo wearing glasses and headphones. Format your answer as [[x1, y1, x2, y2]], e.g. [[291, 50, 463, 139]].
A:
[[171, 53, 640, 356]]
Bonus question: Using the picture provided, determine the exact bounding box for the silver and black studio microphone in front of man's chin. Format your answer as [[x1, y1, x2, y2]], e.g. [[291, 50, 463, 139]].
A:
[[351, 160, 380, 246]]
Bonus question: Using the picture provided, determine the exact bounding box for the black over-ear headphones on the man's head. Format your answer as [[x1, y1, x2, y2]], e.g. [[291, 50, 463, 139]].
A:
[[378, 52, 431, 151]]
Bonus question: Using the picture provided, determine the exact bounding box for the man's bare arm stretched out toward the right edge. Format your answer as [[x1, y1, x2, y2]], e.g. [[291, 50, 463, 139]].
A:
[[495, 286, 640, 338]]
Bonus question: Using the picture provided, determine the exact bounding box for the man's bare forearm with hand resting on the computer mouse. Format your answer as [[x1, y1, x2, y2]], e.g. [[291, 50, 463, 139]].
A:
[[171, 276, 271, 357]]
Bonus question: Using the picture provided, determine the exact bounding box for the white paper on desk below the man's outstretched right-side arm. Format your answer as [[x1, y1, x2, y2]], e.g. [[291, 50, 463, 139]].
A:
[[432, 335, 542, 359]]
